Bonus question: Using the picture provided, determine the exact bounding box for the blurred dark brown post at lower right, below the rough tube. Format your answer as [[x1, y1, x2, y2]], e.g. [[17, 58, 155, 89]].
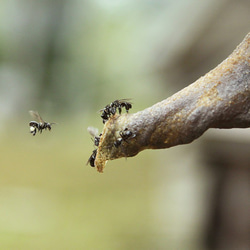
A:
[[204, 135, 250, 250]]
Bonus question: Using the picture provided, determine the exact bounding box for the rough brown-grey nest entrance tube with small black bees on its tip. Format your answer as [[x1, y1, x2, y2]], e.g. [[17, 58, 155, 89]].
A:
[[95, 33, 250, 172]]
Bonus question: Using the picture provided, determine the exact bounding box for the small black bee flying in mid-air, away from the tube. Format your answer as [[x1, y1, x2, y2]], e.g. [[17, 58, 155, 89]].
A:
[[29, 110, 55, 136]]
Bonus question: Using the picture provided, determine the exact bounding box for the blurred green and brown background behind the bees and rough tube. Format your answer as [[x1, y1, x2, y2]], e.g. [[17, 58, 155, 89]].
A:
[[0, 0, 250, 250]]
